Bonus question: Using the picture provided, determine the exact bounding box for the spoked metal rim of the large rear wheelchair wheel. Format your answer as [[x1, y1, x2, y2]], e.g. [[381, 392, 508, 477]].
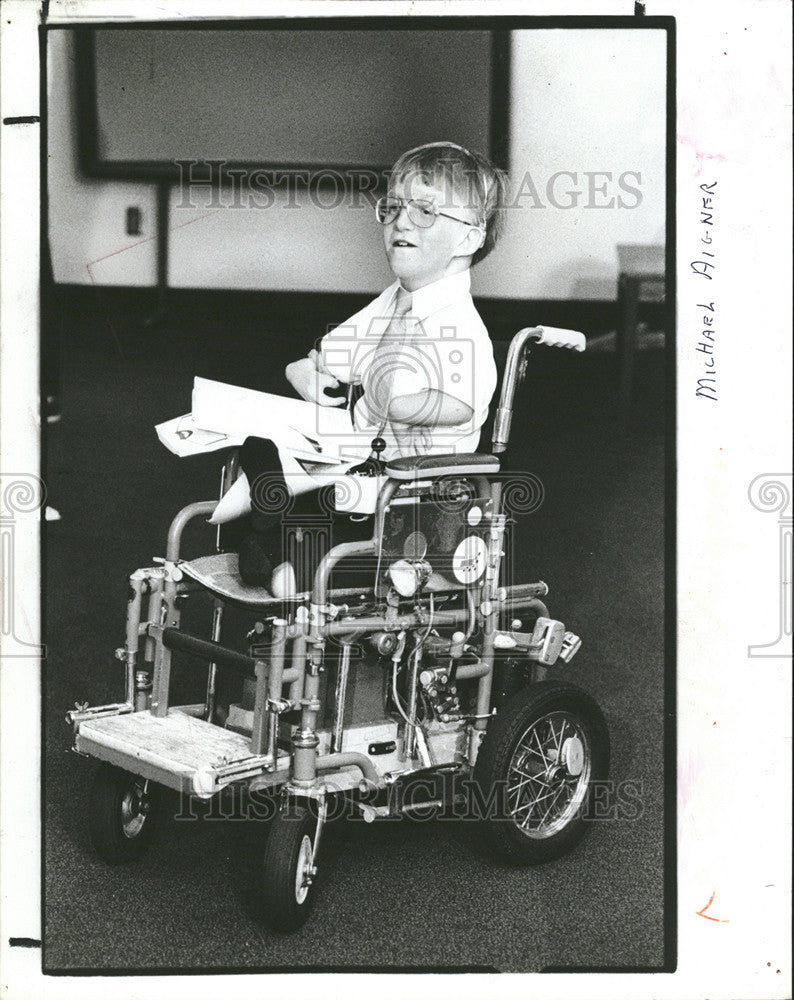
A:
[[507, 712, 592, 840]]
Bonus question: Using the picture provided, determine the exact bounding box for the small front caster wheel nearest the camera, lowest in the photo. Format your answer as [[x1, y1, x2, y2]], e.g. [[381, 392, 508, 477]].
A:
[[260, 806, 317, 933]]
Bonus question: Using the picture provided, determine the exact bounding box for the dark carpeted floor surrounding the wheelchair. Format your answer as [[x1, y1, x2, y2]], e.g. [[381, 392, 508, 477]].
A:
[[40, 300, 665, 972]]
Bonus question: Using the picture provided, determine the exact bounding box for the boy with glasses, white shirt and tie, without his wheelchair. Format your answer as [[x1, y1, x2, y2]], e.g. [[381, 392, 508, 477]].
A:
[[238, 142, 506, 597]]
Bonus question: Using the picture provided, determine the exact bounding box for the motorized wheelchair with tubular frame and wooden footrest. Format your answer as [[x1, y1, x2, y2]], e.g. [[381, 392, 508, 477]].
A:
[[67, 327, 609, 932]]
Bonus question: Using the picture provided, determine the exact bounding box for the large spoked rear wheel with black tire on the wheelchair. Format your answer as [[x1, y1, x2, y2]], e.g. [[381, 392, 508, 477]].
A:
[[473, 681, 610, 865]]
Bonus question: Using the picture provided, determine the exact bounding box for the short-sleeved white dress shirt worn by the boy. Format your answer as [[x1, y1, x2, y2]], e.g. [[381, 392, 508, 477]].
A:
[[320, 270, 496, 458]]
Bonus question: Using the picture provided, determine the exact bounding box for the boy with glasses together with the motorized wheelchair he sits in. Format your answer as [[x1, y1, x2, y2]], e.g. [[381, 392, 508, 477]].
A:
[[67, 143, 609, 931]]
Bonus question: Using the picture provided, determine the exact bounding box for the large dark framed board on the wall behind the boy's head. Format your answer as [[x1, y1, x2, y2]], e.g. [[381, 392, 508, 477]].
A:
[[80, 20, 508, 178]]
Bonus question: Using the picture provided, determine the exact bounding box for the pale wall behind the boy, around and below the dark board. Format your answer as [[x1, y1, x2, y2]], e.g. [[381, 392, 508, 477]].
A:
[[48, 29, 666, 299]]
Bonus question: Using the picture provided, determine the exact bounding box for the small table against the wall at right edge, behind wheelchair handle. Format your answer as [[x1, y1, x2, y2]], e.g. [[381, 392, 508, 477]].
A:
[[617, 243, 665, 427]]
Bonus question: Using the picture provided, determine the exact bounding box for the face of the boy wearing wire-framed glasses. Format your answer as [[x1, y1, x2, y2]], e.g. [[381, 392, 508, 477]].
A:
[[383, 174, 482, 292]]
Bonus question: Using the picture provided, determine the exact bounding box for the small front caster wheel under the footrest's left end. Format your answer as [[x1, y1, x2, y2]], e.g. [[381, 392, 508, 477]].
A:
[[88, 764, 159, 865]]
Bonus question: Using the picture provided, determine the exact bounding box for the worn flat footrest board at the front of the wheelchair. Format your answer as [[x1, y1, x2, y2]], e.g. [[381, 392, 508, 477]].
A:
[[75, 708, 289, 798]]
